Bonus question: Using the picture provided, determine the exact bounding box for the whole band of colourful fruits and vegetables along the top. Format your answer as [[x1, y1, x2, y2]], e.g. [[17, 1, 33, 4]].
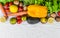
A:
[[0, 0, 60, 25]]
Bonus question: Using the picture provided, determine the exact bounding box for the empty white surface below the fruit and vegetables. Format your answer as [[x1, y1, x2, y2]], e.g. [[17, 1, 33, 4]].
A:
[[0, 8, 60, 38]]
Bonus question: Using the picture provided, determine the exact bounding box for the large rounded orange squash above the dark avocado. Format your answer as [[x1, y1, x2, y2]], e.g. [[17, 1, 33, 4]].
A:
[[27, 5, 48, 18]]
